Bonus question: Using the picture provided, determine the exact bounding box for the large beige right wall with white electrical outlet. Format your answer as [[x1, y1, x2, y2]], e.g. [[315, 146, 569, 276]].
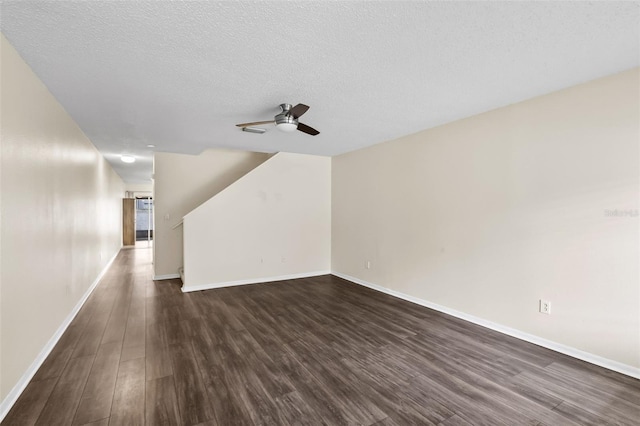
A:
[[332, 69, 640, 367]]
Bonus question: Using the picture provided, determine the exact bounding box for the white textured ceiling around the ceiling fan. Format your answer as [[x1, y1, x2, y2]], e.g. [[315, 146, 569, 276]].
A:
[[0, 1, 640, 183]]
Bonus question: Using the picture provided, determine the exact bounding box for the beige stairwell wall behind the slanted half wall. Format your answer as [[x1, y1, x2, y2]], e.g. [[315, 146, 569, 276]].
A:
[[153, 149, 269, 277]]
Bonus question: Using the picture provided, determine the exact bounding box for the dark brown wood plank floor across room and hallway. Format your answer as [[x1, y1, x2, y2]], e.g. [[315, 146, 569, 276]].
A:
[[2, 249, 640, 426]]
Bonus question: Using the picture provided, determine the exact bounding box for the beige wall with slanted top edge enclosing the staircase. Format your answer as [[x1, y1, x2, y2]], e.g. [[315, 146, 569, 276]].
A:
[[183, 153, 331, 291]]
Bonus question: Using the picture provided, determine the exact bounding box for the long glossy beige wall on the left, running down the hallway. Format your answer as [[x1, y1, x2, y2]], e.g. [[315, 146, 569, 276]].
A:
[[0, 36, 124, 400]]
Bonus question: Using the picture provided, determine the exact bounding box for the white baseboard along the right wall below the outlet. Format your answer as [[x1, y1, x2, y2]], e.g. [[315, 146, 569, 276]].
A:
[[331, 271, 640, 379]]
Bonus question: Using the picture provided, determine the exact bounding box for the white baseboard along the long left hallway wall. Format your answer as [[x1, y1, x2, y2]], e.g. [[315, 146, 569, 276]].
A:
[[0, 247, 124, 422]]
